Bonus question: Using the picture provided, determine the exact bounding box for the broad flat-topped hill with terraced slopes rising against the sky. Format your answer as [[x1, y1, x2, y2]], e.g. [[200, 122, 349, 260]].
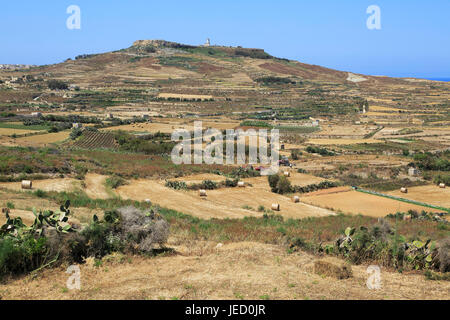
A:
[[0, 40, 450, 120]]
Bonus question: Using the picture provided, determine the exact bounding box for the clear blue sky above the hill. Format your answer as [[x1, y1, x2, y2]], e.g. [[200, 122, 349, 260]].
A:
[[0, 0, 450, 78]]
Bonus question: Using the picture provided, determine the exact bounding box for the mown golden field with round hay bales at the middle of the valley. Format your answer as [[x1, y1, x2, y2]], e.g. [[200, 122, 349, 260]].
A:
[[116, 178, 334, 219]]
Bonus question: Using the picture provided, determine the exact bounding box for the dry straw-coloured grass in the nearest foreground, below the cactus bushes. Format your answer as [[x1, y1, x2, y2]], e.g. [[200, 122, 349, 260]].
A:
[[0, 238, 450, 300]]
